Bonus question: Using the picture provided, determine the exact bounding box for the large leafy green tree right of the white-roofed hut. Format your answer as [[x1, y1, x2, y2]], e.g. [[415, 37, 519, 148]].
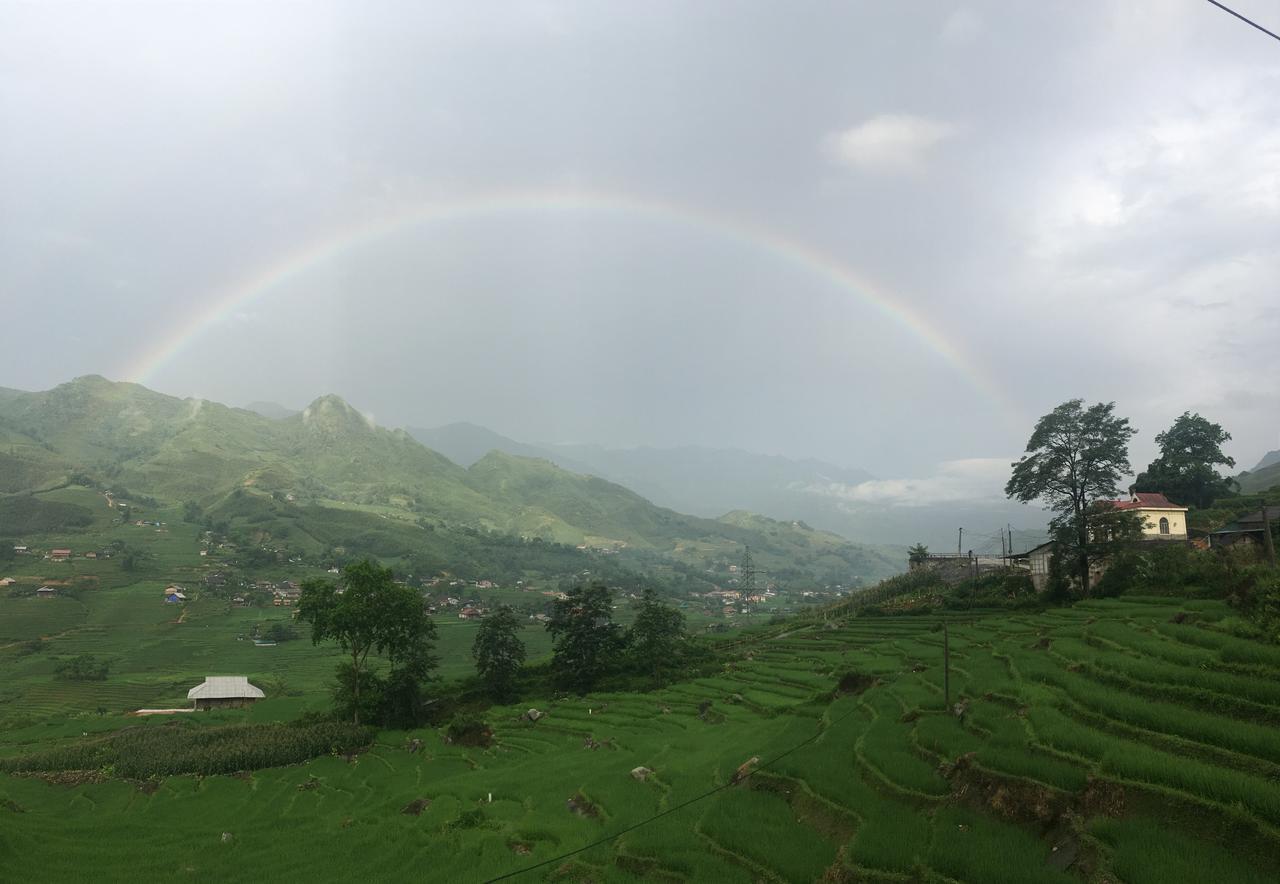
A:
[[298, 559, 436, 724]]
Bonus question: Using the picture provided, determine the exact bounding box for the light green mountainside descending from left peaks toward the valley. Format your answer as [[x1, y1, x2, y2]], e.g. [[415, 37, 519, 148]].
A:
[[0, 377, 901, 586]]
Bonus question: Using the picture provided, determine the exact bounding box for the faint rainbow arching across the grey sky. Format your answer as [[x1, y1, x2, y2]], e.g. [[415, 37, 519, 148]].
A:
[[124, 191, 1016, 416]]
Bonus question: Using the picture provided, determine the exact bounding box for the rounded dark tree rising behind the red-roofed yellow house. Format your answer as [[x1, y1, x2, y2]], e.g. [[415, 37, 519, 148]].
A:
[[1134, 412, 1235, 509]]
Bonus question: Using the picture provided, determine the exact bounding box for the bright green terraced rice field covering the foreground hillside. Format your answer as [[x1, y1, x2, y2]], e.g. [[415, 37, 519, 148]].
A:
[[0, 599, 1280, 884]]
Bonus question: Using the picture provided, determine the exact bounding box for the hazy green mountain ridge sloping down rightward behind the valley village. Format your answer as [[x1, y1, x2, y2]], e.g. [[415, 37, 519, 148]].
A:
[[0, 376, 902, 582]]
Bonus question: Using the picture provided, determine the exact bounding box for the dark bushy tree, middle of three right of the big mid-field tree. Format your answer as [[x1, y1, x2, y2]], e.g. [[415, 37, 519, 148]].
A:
[[547, 583, 622, 693]]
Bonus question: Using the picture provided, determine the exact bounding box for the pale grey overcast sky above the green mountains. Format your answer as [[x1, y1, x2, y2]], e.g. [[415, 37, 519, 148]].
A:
[[0, 0, 1280, 509]]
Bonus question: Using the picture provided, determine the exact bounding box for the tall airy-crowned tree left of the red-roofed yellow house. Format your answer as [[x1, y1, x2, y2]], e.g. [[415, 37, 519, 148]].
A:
[[1005, 399, 1137, 596]]
